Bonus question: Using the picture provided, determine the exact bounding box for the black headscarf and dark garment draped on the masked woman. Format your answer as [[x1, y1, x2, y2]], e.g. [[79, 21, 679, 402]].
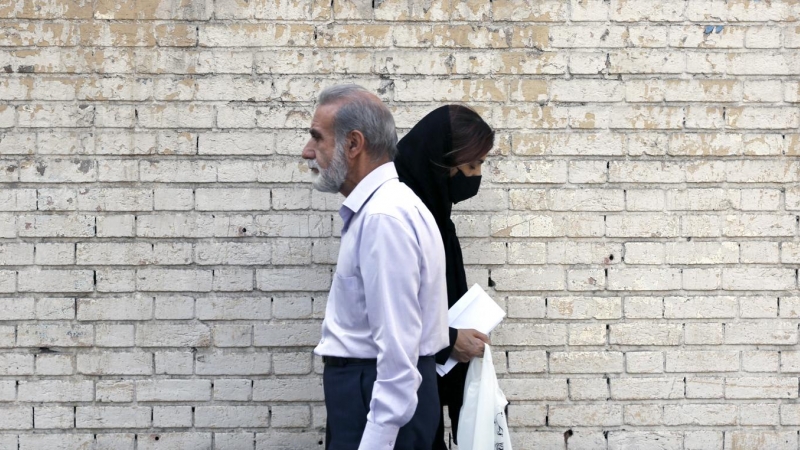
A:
[[394, 106, 468, 440]]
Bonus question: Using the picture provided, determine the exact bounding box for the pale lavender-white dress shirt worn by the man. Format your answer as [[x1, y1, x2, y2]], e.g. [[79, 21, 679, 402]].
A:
[[314, 162, 449, 450]]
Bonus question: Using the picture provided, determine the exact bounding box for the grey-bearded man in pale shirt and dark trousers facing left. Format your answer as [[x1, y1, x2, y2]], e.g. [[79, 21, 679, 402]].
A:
[[303, 85, 449, 450]]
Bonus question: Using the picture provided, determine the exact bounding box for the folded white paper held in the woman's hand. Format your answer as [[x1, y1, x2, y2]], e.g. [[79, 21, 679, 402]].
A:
[[436, 284, 506, 376]]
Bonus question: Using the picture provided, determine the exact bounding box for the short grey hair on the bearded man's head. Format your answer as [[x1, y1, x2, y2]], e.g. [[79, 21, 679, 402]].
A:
[[317, 84, 397, 161]]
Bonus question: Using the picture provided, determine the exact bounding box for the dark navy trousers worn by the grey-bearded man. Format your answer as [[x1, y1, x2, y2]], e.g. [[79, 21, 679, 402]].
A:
[[322, 356, 441, 450]]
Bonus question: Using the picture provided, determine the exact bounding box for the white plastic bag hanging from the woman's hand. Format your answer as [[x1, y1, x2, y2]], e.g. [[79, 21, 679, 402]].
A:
[[458, 345, 511, 450]]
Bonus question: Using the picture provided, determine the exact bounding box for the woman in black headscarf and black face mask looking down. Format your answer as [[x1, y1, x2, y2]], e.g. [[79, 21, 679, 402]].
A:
[[395, 105, 494, 450]]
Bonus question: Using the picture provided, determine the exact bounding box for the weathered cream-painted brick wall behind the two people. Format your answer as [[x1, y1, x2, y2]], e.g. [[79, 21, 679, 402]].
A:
[[0, 0, 800, 450]]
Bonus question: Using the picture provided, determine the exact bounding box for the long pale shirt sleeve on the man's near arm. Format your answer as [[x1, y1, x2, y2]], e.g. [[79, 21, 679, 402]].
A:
[[359, 214, 422, 450]]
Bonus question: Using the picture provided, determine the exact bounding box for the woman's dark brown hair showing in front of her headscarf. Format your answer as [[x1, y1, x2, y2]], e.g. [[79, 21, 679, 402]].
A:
[[444, 105, 494, 167]]
